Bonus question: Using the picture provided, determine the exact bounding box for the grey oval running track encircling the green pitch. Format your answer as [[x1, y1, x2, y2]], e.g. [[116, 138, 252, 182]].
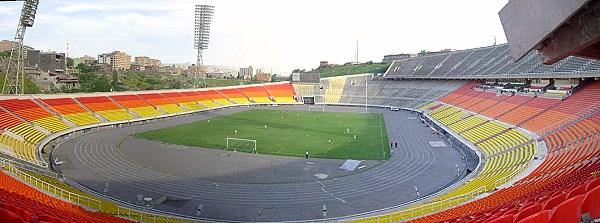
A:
[[53, 106, 465, 221]]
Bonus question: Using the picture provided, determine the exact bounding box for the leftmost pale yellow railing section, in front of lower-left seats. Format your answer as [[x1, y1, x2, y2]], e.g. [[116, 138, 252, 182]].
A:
[[3, 163, 102, 210]]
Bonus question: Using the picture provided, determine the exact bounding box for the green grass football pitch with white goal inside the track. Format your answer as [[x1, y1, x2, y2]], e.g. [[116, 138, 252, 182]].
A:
[[136, 110, 390, 160]]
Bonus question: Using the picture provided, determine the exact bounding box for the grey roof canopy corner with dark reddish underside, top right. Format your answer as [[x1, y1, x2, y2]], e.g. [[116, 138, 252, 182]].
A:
[[499, 0, 600, 64]]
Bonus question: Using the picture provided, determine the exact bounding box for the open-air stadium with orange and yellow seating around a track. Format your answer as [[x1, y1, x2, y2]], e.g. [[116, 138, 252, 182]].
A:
[[0, 0, 600, 223]]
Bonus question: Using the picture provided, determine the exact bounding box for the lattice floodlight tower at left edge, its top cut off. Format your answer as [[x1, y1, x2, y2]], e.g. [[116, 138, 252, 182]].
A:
[[2, 0, 39, 95]]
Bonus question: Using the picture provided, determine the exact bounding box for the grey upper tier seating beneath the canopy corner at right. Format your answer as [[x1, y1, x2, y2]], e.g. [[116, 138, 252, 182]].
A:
[[384, 44, 600, 78]]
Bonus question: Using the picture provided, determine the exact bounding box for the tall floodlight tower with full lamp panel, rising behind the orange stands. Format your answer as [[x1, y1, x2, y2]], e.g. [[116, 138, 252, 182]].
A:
[[194, 5, 215, 85]]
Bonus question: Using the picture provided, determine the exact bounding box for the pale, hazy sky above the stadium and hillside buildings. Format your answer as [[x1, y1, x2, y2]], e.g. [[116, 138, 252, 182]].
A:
[[0, 0, 508, 74]]
